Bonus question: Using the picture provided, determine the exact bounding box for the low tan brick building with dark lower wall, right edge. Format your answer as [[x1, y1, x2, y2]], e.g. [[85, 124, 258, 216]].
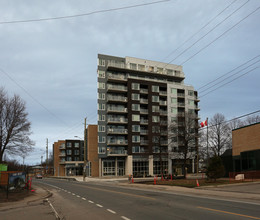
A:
[[232, 123, 260, 172]]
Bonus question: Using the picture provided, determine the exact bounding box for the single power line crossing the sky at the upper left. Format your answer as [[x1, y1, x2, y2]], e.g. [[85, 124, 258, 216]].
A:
[[0, 0, 171, 24]]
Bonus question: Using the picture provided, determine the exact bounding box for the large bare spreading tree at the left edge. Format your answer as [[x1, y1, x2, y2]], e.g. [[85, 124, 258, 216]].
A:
[[0, 88, 34, 163]]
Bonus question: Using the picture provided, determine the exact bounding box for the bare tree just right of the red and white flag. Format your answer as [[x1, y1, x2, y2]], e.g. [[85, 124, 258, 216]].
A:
[[208, 113, 232, 156]]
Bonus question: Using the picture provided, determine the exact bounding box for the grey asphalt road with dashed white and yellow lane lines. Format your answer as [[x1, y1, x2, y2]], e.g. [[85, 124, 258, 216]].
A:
[[37, 179, 260, 220]]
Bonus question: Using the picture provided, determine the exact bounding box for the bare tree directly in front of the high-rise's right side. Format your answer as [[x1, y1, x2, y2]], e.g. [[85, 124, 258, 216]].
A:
[[169, 112, 198, 177]]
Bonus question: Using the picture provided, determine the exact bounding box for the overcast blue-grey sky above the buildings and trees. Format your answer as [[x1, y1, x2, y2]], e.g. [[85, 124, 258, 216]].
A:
[[0, 0, 260, 164]]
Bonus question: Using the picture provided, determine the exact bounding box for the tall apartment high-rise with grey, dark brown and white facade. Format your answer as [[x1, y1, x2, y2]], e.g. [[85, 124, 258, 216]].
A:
[[97, 54, 199, 176]]
